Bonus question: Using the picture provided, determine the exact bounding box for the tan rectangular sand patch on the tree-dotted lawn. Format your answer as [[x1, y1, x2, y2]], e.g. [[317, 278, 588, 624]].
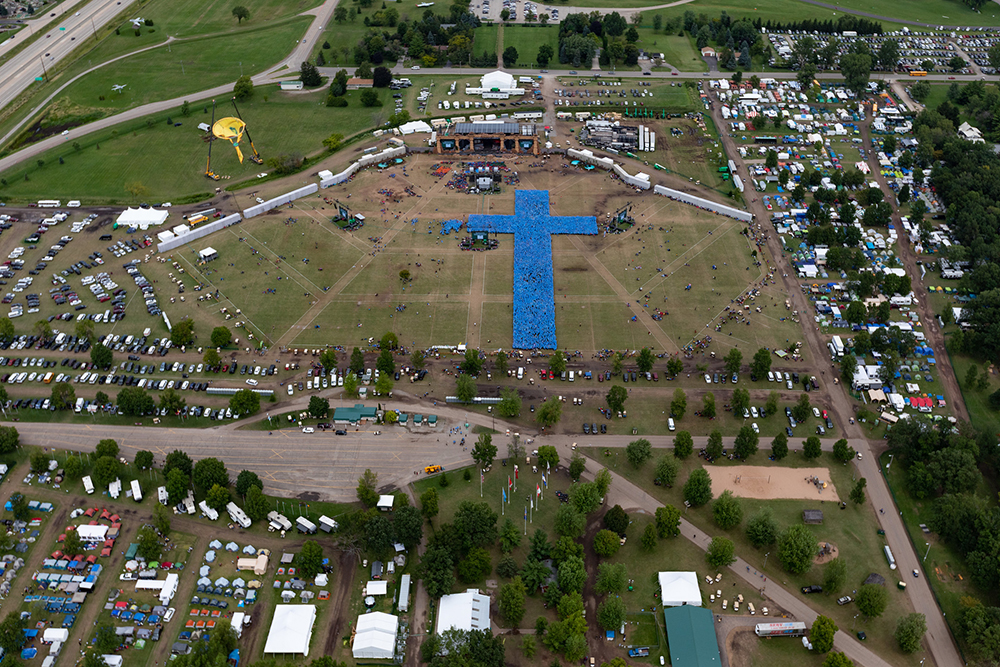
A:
[[705, 466, 839, 501]]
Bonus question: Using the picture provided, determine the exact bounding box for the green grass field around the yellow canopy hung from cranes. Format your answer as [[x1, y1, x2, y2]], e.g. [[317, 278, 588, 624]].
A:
[[3, 86, 392, 204]]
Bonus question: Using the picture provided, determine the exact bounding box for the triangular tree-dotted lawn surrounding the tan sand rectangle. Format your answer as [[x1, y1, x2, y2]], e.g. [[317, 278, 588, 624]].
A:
[[583, 445, 919, 666]]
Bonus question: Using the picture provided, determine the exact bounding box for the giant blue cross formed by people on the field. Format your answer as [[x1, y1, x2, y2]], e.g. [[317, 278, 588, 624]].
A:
[[469, 190, 597, 350]]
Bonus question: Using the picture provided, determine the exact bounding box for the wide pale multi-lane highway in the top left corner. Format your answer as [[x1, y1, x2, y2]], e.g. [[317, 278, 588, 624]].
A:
[[0, 0, 134, 108]]
